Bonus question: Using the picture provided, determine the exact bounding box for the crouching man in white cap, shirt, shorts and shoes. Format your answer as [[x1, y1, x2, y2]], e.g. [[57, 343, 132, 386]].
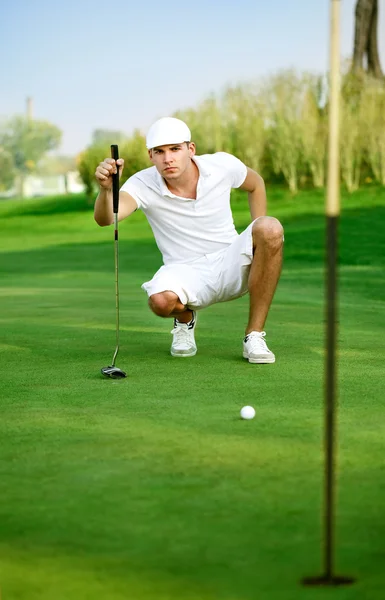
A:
[[94, 117, 283, 363]]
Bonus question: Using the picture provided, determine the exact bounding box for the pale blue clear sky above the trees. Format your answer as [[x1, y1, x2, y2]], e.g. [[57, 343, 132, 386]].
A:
[[0, 0, 385, 155]]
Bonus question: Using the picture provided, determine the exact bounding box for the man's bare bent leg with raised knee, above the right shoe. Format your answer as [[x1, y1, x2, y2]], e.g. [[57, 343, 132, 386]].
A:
[[245, 217, 283, 335]]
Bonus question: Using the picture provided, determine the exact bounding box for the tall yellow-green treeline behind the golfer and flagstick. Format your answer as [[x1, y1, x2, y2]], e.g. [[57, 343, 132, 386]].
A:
[[78, 71, 385, 193]]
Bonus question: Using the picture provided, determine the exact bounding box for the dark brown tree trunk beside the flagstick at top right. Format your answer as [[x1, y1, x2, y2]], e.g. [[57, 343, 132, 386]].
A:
[[352, 0, 383, 79]]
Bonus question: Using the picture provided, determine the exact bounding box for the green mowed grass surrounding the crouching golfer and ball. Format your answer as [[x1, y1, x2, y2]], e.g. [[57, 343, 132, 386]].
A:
[[0, 188, 385, 600]]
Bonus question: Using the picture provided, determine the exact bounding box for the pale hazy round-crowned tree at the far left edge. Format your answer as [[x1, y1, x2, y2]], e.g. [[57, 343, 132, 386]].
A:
[[0, 116, 61, 197]]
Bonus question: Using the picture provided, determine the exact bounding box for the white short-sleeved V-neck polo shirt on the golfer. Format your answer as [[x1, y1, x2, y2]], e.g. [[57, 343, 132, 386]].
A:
[[121, 152, 247, 265]]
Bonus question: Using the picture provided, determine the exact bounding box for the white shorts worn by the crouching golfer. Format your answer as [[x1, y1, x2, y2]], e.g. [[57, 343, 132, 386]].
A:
[[142, 222, 254, 310]]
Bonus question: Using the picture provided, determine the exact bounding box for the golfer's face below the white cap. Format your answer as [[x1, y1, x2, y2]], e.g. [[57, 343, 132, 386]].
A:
[[148, 142, 195, 181]]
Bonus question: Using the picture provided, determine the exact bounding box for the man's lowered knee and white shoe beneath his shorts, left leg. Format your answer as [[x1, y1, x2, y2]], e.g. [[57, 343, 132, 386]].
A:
[[148, 291, 197, 358]]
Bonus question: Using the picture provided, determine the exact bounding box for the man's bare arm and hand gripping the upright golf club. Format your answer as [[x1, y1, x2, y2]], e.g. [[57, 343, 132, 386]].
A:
[[94, 158, 138, 227]]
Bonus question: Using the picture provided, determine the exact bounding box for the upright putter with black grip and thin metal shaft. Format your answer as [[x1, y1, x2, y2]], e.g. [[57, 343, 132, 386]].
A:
[[101, 144, 127, 379]]
